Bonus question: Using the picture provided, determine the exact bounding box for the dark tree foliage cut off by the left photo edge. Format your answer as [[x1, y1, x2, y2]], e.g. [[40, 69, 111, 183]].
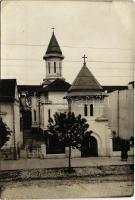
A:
[[0, 118, 11, 149]]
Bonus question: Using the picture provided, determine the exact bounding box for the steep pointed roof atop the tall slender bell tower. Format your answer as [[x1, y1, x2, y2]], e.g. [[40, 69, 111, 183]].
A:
[[44, 32, 63, 59]]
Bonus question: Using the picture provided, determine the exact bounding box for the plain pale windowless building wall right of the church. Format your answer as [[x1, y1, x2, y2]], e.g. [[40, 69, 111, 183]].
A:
[[104, 82, 134, 140]]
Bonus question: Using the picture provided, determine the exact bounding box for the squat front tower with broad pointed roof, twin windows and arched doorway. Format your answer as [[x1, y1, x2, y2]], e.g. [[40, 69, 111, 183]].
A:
[[67, 61, 112, 156]]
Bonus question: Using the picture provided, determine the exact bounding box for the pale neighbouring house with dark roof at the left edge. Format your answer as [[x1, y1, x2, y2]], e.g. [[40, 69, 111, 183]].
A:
[[0, 79, 23, 148]]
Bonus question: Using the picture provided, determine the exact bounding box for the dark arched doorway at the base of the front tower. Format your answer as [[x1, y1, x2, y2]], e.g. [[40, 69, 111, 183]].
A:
[[81, 135, 98, 157]]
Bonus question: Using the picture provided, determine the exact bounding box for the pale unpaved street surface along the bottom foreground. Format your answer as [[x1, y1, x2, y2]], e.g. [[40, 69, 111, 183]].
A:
[[1, 174, 133, 199]]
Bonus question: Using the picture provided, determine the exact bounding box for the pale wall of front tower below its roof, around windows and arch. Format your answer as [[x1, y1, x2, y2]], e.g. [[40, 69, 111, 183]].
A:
[[68, 99, 112, 156]]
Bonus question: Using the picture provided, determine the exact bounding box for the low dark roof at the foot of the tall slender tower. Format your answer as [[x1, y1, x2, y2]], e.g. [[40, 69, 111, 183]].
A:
[[41, 79, 71, 92]]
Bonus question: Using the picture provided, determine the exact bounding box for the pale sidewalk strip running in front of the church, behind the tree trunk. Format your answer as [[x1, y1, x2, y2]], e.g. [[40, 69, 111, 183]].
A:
[[0, 157, 134, 170]]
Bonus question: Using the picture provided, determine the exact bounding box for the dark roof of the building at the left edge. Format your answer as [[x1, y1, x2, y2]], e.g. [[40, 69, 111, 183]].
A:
[[0, 79, 16, 102]]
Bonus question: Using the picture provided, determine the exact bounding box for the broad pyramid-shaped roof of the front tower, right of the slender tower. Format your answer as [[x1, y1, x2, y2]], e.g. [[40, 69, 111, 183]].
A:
[[68, 64, 102, 93]]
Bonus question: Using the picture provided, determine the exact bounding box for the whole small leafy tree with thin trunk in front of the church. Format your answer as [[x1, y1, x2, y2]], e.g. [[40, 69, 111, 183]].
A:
[[48, 112, 90, 172]]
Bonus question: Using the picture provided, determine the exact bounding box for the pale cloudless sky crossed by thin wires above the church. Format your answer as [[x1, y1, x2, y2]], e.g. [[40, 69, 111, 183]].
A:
[[1, 0, 135, 85]]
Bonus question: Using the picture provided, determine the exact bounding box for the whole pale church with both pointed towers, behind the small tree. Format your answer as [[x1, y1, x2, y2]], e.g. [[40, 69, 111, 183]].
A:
[[17, 31, 118, 157]]
